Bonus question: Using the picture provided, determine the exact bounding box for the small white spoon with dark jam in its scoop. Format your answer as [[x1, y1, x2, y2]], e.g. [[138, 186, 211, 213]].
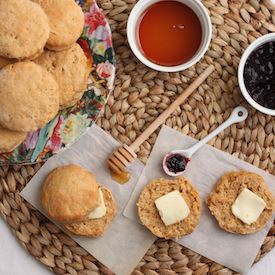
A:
[[162, 106, 248, 177]]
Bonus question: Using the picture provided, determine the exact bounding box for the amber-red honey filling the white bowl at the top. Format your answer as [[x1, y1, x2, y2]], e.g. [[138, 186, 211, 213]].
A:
[[138, 1, 202, 66]]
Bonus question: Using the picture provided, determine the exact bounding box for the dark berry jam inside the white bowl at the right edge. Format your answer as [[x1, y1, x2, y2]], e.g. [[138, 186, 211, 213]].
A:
[[244, 42, 275, 109]]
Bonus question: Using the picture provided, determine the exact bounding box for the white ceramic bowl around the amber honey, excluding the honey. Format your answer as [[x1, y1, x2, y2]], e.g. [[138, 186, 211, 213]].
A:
[[127, 0, 212, 72]]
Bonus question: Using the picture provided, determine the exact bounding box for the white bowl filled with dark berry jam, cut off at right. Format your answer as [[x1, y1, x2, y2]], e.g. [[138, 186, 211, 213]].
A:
[[238, 33, 275, 116]]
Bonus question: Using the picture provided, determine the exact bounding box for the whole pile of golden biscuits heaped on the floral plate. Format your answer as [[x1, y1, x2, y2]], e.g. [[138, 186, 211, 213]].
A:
[[0, 0, 89, 153]]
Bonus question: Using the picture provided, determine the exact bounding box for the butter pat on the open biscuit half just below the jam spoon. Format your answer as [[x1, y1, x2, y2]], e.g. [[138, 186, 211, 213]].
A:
[[155, 190, 190, 226]]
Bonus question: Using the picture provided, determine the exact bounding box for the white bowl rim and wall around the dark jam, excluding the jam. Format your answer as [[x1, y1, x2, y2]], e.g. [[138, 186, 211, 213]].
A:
[[238, 33, 275, 116]]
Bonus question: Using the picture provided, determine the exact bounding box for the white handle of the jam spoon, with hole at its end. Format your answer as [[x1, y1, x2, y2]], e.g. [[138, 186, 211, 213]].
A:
[[184, 106, 248, 158]]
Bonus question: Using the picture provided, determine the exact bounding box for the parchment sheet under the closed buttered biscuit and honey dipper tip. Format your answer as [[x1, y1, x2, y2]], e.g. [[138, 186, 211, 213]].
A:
[[21, 125, 155, 275]]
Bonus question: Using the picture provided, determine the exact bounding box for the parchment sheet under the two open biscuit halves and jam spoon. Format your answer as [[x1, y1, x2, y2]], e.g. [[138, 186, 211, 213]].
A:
[[124, 126, 275, 273]]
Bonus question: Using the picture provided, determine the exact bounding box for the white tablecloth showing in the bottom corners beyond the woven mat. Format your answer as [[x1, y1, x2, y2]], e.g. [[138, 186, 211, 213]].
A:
[[0, 219, 275, 275]]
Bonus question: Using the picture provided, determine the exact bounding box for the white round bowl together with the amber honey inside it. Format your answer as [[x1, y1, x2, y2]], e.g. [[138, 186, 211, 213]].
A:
[[127, 0, 212, 72]]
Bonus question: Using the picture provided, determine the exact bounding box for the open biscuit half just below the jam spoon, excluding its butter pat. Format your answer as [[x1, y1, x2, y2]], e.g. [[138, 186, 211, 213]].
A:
[[137, 177, 201, 239]]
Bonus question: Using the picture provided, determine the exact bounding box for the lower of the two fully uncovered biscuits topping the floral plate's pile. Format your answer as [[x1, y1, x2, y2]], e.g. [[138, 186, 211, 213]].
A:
[[0, 61, 59, 132]]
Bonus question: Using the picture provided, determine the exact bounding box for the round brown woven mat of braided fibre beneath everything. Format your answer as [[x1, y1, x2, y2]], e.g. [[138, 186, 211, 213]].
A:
[[0, 0, 275, 275]]
